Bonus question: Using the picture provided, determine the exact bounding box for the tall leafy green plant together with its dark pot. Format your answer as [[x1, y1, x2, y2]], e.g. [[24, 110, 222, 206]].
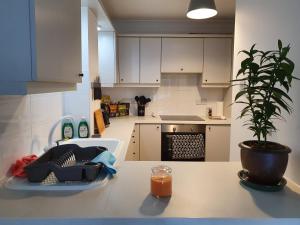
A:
[[232, 40, 299, 186]]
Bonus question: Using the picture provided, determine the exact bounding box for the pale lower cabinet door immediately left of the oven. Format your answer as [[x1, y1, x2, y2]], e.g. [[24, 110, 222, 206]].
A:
[[140, 124, 161, 161]]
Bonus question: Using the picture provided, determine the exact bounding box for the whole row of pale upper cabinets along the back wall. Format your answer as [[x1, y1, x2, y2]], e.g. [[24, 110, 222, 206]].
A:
[[109, 35, 232, 88]]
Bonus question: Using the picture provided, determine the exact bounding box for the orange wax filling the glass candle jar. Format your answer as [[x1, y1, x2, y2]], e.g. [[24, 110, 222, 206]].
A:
[[151, 175, 172, 197]]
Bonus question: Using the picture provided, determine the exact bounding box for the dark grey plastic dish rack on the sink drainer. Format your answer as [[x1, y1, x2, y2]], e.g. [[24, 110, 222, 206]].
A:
[[24, 144, 107, 183]]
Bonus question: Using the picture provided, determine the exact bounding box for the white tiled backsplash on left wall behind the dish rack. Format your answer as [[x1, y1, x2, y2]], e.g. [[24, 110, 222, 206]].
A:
[[0, 93, 63, 179]]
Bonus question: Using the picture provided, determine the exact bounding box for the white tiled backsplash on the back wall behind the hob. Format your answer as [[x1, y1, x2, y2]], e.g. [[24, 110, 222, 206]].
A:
[[103, 74, 230, 116]]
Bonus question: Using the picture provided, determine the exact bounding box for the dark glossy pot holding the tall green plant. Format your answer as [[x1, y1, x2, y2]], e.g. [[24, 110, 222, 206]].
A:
[[239, 141, 291, 185]]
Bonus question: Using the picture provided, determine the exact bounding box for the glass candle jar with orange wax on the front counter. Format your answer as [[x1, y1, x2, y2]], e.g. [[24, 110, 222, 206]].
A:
[[151, 166, 172, 198]]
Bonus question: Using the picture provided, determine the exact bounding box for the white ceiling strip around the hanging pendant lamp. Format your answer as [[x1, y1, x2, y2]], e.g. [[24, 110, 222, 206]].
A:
[[101, 0, 235, 20]]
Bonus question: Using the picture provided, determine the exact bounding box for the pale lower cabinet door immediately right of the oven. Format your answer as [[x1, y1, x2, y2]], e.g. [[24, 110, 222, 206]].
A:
[[205, 125, 230, 162]]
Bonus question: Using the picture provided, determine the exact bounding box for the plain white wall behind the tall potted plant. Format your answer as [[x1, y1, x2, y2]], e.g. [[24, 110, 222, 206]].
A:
[[231, 0, 300, 183]]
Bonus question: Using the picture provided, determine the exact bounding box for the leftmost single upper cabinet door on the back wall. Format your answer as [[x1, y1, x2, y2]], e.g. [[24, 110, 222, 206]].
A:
[[118, 37, 140, 83]]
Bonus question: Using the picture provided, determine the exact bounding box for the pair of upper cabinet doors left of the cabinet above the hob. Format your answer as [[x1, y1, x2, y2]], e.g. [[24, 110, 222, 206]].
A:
[[118, 37, 161, 85]]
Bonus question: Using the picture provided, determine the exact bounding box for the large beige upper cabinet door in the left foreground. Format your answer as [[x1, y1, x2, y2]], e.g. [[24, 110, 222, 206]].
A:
[[31, 0, 82, 83]]
